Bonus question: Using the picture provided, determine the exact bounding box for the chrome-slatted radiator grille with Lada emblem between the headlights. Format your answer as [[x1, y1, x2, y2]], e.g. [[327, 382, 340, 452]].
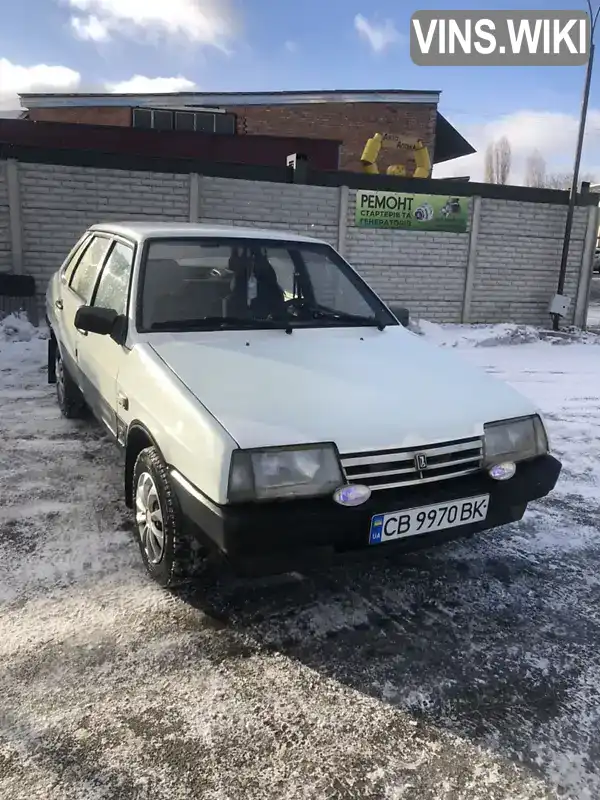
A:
[[341, 437, 483, 491]]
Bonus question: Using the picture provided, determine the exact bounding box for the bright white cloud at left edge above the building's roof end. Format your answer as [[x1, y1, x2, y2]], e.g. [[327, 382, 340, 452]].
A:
[[0, 58, 81, 110]]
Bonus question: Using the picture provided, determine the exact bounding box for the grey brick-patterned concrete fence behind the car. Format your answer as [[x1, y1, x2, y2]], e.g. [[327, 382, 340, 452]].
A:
[[0, 159, 598, 325]]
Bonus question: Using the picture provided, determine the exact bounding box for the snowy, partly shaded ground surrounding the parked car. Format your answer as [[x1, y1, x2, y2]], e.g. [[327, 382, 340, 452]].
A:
[[0, 319, 600, 800]]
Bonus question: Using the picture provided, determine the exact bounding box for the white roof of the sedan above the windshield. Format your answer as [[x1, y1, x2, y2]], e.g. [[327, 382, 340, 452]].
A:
[[89, 221, 326, 244]]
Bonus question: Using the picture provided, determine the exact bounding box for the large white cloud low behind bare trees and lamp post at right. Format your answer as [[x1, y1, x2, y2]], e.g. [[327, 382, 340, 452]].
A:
[[433, 110, 600, 184]]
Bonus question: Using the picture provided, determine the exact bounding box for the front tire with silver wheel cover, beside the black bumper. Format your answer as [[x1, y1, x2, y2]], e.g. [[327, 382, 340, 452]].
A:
[[132, 447, 196, 589]]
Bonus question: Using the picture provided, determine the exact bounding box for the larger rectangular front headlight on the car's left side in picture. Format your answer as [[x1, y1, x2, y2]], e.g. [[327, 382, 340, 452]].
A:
[[228, 444, 343, 503]]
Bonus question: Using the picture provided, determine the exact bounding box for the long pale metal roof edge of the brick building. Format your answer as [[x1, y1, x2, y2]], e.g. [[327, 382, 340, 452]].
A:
[[19, 89, 440, 108]]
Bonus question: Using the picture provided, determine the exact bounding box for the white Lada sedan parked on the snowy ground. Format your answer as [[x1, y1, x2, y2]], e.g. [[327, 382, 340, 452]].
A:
[[46, 222, 561, 586]]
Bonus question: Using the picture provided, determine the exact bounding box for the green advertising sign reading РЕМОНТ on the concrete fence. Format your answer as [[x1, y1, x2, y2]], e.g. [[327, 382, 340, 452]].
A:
[[356, 189, 469, 233]]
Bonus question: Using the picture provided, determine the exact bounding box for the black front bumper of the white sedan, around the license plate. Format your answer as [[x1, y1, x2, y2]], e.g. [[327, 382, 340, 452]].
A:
[[173, 455, 561, 562]]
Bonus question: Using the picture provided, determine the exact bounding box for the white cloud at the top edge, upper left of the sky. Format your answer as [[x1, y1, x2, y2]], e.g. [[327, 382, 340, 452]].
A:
[[63, 0, 236, 51]]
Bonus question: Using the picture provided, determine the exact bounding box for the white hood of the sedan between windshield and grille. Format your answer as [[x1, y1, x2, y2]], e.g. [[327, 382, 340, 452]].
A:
[[148, 326, 537, 453]]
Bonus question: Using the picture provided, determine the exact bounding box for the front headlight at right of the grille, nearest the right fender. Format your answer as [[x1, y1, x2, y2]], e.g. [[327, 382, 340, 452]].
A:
[[484, 415, 548, 467]]
